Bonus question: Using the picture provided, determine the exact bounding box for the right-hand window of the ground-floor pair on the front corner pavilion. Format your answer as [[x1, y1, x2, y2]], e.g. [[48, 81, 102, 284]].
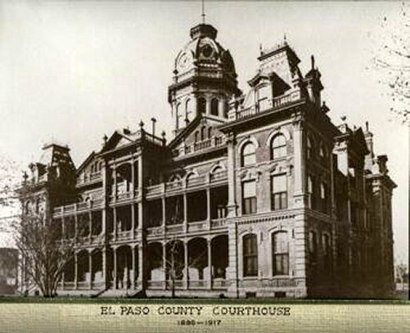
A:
[[272, 231, 289, 275]]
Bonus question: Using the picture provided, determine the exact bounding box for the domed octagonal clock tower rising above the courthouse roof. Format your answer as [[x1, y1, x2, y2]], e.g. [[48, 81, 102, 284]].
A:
[[168, 24, 241, 134]]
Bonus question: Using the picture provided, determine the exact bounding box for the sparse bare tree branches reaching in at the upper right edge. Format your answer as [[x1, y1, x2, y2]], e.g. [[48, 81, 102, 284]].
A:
[[371, 2, 410, 125]]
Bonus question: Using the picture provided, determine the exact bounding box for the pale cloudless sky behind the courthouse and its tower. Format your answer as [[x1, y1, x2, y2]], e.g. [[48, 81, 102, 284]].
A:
[[0, 1, 409, 262]]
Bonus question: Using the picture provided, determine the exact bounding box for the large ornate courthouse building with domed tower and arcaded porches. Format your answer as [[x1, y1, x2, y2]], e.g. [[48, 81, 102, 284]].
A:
[[21, 24, 396, 298]]
